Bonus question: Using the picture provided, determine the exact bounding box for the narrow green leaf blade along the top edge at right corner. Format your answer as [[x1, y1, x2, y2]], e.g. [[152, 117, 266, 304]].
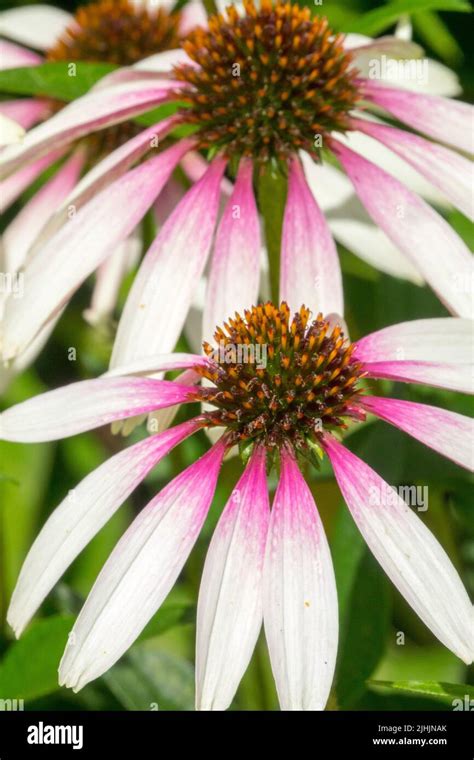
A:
[[344, 0, 471, 36]]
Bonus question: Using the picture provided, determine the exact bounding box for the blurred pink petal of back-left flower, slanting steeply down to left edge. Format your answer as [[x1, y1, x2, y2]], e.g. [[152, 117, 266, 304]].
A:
[[3, 150, 85, 272]]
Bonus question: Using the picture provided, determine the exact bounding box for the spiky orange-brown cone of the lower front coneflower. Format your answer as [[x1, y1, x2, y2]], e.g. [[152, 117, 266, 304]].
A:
[[197, 302, 362, 447]]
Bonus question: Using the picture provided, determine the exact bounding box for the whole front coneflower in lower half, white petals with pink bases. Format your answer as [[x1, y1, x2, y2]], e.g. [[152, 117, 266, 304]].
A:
[[0, 294, 474, 710]]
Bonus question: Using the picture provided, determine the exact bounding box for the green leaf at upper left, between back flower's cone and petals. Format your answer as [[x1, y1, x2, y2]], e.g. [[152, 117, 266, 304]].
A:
[[0, 61, 117, 101]]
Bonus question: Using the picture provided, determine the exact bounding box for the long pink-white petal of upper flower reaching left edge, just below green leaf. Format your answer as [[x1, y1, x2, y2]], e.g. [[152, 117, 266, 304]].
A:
[[0, 79, 181, 177]]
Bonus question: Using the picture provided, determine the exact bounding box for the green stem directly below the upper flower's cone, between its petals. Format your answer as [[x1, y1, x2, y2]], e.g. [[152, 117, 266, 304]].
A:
[[258, 162, 288, 304]]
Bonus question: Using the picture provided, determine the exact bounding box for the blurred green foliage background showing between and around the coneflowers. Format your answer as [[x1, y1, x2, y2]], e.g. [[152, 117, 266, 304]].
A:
[[0, 0, 474, 710]]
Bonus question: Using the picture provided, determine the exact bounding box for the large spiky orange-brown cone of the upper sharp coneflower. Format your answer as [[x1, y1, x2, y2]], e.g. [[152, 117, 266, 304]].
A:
[[175, 0, 357, 161]]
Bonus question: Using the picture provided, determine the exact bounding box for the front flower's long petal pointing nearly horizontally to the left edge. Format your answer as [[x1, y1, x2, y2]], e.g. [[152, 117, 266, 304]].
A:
[[0, 377, 192, 443]]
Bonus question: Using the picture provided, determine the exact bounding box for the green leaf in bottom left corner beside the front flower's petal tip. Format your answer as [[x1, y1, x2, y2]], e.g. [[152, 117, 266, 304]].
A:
[[0, 615, 74, 702]]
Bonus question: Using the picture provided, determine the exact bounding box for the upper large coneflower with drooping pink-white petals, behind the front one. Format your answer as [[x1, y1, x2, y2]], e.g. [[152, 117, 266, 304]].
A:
[[0, 0, 472, 386]]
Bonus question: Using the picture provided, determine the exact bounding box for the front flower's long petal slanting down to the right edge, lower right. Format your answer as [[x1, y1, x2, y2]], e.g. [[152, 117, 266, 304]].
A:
[[325, 436, 474, 663]]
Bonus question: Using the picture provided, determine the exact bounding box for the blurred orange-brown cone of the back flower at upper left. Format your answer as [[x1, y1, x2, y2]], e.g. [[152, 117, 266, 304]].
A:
[[46, 0, 180, 158]]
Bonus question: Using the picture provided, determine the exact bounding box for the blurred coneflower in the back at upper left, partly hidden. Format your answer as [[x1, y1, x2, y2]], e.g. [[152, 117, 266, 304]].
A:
[[0, 0, 205, 388]]
